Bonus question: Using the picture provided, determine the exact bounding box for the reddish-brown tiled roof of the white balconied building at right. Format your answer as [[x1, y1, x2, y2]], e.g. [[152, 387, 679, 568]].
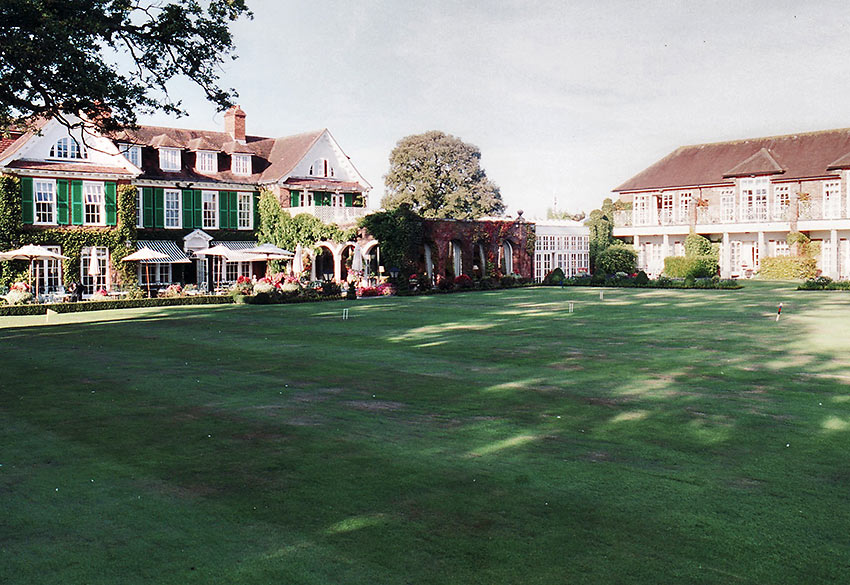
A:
[[614, 128, 850, 191]]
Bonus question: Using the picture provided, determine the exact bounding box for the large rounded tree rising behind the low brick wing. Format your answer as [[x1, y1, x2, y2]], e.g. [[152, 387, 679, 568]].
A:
[[381, 130, 505, 219]]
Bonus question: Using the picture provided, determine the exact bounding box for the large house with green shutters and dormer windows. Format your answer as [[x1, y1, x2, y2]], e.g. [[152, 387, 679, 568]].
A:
[[0, 106, 371, 294]]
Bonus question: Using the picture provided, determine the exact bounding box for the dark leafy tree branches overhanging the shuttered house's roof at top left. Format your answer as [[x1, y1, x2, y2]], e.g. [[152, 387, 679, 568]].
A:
[[0, 0, 251, 131]]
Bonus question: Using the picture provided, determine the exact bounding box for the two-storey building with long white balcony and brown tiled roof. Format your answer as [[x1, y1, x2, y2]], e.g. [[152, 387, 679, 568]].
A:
[[614, 129, 850, 278]]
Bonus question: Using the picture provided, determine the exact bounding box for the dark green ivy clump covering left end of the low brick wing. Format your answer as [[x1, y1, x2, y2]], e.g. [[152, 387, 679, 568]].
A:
[[358, 204, 424, 279]]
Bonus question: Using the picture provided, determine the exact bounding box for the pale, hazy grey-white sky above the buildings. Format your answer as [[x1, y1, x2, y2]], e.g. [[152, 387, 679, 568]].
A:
[[134, 0, 850, 218]]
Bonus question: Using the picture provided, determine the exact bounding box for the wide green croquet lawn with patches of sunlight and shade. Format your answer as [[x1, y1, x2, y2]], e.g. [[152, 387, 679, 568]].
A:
[[0, 283, 850, 585]]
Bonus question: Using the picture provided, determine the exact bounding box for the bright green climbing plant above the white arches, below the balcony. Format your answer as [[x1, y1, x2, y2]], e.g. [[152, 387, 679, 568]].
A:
[[257, 190, 342, 251]]
